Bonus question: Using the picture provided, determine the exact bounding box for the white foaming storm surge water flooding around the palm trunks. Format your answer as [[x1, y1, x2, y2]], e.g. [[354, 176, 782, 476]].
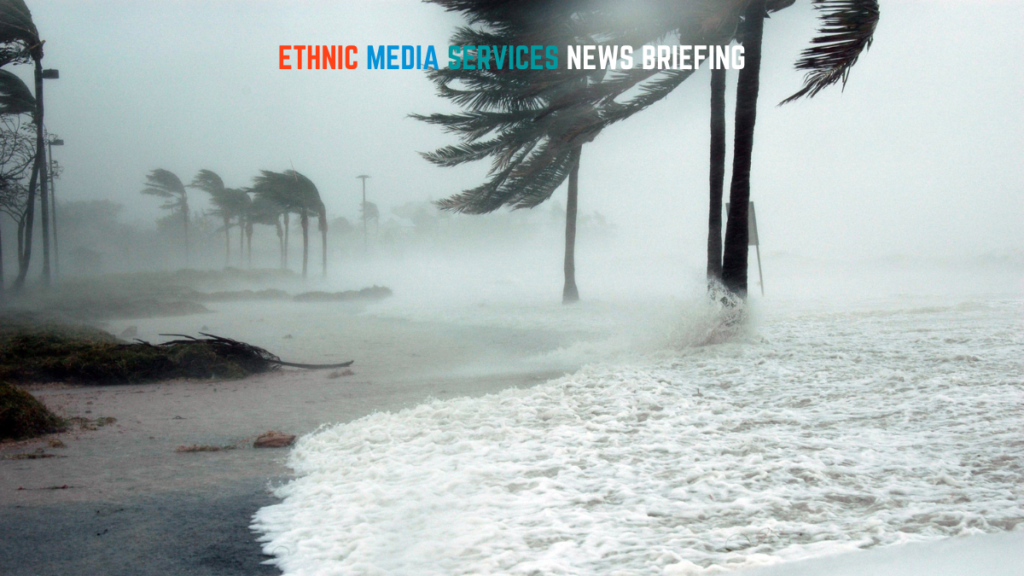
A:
[[253, 298, 1024, 576]]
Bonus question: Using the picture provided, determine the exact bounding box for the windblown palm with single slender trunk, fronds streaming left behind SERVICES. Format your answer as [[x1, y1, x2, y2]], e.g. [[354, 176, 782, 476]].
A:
[[414, 0, 604, 303]]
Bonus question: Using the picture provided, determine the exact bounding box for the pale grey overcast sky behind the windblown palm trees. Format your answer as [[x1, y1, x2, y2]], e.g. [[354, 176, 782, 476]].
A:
[[24, 0, 1024, 257]]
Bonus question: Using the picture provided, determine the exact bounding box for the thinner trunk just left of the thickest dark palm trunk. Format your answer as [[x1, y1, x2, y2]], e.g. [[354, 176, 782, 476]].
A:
[[708, 68, 726, 282]]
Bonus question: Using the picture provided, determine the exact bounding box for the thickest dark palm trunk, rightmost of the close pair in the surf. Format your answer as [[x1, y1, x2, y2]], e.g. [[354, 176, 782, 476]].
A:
[[722, 0, 765, 298]]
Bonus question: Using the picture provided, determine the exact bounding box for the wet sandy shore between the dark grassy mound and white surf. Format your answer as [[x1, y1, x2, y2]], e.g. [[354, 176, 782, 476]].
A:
[[0, 305, 575, 575]]
